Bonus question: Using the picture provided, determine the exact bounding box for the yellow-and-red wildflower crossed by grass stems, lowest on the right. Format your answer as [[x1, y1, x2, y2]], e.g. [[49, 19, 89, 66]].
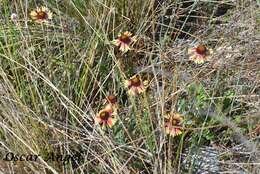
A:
[[164, 113, 183, 137]]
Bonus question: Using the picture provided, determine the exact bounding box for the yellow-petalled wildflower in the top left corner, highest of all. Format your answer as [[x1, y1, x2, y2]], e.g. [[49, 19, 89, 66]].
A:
[[30, 7, 52, 23]]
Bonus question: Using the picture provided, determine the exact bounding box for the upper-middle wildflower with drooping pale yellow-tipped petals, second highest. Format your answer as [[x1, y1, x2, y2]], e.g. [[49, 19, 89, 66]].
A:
[[112, 31, 136, 53]]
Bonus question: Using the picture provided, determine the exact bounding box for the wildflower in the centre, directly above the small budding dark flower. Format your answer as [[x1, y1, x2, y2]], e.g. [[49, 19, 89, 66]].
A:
[[125, 75, 145, 95]]
